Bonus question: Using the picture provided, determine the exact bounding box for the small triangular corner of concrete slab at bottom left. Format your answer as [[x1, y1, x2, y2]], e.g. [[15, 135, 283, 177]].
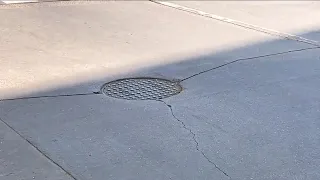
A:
[[0, 121, 73, 180]]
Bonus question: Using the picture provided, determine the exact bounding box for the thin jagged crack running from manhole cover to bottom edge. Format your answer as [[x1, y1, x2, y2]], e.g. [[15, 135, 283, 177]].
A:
[[156, 100, 231, 179]]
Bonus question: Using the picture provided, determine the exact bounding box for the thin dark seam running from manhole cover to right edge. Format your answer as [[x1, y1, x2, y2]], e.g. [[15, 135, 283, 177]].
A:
[[180, 47, 320, 82]]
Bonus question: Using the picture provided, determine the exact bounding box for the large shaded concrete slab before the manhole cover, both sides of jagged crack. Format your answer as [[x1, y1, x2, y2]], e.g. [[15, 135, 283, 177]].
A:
[[0, 46, 320, 180]]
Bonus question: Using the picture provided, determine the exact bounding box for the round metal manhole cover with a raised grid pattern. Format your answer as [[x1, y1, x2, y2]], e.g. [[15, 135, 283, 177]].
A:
[[102, 78, 182, 100]]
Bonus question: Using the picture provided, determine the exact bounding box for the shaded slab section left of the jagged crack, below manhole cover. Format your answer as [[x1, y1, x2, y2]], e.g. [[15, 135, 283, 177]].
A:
[[0, 95, 228, 180]]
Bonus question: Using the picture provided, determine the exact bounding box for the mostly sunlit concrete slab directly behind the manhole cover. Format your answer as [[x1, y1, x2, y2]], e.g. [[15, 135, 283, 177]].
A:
[[0, 1, 313, 99]]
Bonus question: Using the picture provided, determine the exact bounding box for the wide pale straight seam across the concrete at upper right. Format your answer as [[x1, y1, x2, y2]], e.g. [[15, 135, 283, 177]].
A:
[[149, 0, 320, 46]]
